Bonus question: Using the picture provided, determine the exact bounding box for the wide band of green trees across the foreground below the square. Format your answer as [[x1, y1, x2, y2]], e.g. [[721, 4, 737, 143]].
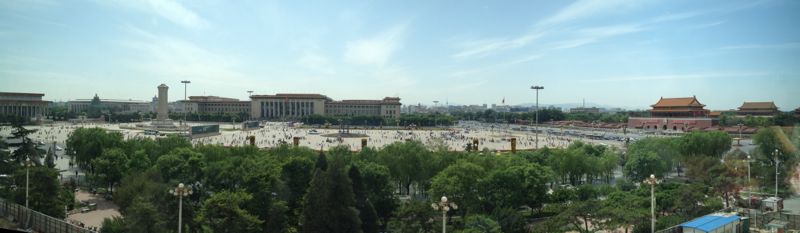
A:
[[56, 124, 797, 232]]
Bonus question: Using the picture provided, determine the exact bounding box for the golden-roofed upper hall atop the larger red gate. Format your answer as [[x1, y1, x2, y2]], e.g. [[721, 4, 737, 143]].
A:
[[650, 96, 710, 117]]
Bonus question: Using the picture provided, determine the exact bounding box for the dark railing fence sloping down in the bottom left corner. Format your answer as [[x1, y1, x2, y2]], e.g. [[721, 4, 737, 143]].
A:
[[0, 198, 94, 233]]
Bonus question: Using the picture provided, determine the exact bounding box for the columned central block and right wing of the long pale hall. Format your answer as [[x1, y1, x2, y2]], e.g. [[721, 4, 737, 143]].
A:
[[250, 94, 402, 120]]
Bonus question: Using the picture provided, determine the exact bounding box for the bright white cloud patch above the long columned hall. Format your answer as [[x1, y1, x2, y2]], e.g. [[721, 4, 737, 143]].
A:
[[344, 24, 406, 65]]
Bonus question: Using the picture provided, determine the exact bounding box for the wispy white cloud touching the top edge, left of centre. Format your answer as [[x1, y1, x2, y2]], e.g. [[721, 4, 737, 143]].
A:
[[110, 0, 208, 29]]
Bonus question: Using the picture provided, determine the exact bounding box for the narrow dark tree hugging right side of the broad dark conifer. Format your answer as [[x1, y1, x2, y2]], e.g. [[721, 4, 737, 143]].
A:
[[347, 166, 378, 233]]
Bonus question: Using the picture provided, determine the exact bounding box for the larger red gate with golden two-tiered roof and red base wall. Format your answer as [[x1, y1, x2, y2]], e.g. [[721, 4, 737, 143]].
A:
[[628, 96, 714, 132]]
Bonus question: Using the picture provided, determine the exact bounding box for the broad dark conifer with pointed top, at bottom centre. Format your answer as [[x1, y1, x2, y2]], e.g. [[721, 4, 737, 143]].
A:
[[301, 156, 361, 233]]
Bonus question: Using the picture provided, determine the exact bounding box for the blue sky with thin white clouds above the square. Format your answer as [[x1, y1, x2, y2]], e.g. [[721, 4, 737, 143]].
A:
[[0, 0, 800, 111]]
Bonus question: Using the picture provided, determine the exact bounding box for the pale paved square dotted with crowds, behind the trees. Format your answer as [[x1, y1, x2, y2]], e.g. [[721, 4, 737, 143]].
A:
[[0, 122, 632, 153]]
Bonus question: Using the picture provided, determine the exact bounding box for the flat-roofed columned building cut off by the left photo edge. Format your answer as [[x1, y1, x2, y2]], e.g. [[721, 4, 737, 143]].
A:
[[0, 92, 50, 119]]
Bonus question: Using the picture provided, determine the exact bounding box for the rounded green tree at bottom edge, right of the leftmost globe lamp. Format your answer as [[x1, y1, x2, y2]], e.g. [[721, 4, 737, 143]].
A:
[[195, 191, 263, 232]]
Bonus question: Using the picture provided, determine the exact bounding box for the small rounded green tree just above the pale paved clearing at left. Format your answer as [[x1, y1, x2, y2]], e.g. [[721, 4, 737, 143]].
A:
[[92, 148, 128, 193]]
